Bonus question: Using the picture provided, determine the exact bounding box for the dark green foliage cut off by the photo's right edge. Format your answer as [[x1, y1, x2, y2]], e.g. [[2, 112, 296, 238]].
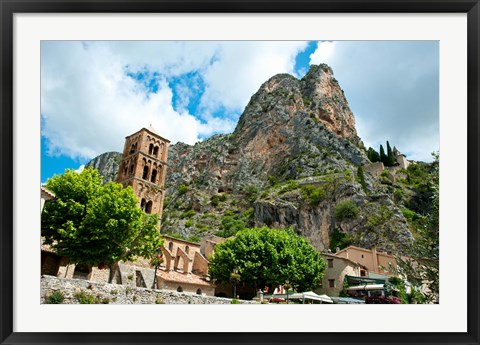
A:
[[397, 153, 439, 303]]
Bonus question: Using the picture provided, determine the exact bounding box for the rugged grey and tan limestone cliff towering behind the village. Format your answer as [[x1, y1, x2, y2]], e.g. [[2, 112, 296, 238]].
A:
[[87, 65, 412, 251]]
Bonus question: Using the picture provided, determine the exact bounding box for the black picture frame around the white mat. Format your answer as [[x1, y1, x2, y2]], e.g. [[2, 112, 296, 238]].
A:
[[0, 0, 480, 344]]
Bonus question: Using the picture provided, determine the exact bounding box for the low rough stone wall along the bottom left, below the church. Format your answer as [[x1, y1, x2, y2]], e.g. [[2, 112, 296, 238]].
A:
[[40, 275, 258, 304]]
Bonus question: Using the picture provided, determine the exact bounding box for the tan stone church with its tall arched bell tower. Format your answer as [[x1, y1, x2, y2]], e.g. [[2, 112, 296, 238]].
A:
[[41, 126, 221, 296]]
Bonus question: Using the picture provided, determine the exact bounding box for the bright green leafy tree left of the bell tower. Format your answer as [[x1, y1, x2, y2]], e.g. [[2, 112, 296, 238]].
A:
[[42, 168, 163, 282]]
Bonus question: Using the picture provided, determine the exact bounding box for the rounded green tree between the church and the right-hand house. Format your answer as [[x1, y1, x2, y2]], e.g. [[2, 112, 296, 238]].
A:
[[209, 227, 325, 291]]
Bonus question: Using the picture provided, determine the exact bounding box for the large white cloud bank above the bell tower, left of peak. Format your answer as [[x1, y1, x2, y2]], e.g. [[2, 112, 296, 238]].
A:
[[41, 41, 306, 159]]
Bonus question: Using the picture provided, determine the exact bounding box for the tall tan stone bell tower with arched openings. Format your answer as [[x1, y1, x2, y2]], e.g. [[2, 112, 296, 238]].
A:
[[117, 125, 170, 226]]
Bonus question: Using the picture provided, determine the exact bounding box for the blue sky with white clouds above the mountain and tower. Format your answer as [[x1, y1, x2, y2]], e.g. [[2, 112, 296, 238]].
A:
[[41, 41, 439, 182]]
